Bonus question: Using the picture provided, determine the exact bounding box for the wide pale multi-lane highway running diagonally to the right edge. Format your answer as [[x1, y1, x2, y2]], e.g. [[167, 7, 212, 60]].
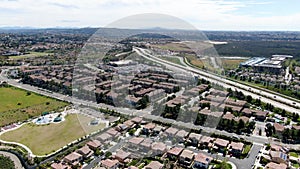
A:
[[133, 47, 300, 115]]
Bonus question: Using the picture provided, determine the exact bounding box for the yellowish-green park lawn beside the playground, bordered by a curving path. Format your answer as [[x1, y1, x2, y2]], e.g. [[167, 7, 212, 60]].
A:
[[0, 114, 105, 155]]
